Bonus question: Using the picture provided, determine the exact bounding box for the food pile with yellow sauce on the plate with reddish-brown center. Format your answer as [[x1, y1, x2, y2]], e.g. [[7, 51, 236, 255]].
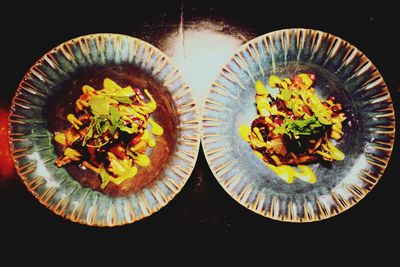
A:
[[54, 78, 164, 189]]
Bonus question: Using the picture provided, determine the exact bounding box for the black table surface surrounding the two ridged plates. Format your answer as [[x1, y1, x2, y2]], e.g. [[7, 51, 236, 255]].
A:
[[0, 0, 400, 266]]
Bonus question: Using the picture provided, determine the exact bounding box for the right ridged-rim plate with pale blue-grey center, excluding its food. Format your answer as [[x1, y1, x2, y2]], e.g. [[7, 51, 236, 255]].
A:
[[202, 29, 395, 222]]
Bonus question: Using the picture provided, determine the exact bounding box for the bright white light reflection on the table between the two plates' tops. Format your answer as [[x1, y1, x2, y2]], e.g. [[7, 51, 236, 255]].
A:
[[162, 22, 245, 108]]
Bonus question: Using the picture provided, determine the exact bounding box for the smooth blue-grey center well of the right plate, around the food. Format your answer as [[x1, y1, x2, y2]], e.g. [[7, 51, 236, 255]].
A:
[[229, 62, 366, 196]]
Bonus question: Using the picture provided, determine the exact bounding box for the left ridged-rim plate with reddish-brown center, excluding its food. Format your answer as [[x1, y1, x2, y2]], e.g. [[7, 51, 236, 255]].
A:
[[9, 34, 200, 226]]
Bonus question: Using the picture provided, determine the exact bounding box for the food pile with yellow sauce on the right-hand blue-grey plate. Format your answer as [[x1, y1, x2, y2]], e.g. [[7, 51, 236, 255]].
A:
[[239, 73, 346, 183]]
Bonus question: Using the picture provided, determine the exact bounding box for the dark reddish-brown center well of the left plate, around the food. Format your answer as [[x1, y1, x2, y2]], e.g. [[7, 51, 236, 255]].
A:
[[45, 65, 178, 196]]
